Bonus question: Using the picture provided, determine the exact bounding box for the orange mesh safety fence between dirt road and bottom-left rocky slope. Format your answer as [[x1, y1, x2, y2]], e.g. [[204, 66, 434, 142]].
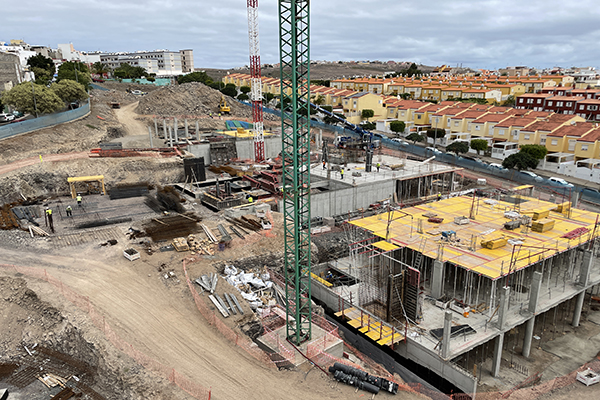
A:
[[0, 264, 211, 400]]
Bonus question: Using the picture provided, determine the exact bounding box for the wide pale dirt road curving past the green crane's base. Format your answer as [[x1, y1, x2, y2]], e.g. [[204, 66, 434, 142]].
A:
[[0, 245, 422, 400]]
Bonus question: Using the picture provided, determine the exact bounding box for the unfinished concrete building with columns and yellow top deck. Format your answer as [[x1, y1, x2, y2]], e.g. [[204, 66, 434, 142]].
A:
[[313, 187, 600, 393]]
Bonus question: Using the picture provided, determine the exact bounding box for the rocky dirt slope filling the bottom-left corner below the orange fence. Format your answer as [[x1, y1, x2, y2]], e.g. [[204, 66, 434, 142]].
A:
[[0, 276, 188, 399]]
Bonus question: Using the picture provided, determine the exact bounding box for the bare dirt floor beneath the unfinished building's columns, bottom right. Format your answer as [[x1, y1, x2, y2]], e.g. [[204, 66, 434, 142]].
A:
[[477, 311, 600, 392]]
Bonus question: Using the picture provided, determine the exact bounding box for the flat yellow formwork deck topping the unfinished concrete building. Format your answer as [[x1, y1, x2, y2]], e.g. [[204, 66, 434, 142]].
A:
[[350, 195, 600, 279]]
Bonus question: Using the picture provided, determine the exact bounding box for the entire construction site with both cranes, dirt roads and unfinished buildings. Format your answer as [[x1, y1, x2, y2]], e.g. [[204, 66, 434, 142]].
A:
[[0, 1, 600, 400]]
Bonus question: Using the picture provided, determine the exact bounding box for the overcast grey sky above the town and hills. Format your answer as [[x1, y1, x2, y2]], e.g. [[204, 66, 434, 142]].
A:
[[0, 0, 600, 69]]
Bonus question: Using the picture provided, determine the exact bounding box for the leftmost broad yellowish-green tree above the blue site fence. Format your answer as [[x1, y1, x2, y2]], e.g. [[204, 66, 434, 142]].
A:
[[2, 82, 65, 115]]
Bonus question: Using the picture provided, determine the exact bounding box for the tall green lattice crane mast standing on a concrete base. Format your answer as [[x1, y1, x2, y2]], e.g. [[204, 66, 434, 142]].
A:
[[279, 0, 312, 345]]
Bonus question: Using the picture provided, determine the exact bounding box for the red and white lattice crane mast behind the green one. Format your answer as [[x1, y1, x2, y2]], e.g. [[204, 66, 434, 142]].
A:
[[248, 0, 265, 162]]
